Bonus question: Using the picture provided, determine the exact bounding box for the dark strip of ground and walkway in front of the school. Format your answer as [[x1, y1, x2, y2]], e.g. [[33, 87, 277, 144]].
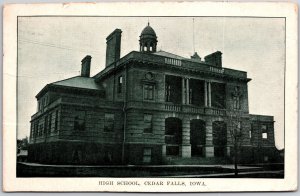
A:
[[17, 163, 284, 178]]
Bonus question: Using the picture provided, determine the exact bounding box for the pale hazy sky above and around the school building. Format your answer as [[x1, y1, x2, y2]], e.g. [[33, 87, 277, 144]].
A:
[[17, 17, 285, 149]]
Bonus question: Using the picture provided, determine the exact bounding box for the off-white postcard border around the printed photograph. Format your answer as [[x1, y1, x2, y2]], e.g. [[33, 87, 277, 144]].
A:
[[3, 2, 298, 192]]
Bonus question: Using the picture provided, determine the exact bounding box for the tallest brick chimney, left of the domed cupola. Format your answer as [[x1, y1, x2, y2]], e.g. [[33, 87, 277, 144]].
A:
[[105, 29, 122, 67]]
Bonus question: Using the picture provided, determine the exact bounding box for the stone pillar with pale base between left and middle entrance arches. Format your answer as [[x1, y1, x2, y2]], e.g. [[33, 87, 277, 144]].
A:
[[179, 118, 191, 158]]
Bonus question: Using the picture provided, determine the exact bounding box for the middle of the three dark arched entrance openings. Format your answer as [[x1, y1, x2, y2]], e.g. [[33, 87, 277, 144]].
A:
[[190, 119, 205, 157]]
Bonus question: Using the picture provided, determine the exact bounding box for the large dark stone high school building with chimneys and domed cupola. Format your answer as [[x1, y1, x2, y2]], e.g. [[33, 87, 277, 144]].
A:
[[28, 24, 278, 164]]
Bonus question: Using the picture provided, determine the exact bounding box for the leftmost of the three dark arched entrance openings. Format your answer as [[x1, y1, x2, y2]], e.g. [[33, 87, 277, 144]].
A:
[[165, 117, 182, 156]]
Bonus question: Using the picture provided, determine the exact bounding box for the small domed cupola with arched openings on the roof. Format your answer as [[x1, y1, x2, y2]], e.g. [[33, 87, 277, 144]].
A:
[[140, 22, 157, 53]]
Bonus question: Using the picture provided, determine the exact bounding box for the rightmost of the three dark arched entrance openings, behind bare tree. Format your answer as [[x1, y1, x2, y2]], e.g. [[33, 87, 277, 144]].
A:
[[212, 121, 227, 157]]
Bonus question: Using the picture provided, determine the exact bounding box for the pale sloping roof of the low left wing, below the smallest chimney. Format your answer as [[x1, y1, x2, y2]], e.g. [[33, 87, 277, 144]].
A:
[[51, 76, 102, 90]]
